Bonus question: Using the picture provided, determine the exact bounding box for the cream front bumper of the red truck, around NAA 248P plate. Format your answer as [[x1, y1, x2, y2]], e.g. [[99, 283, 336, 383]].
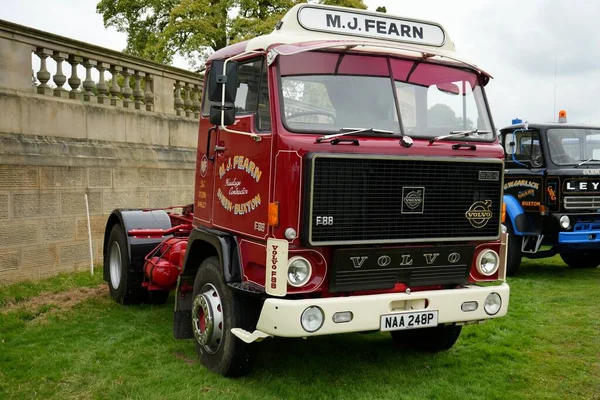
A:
[[232, 283, 510, 342]]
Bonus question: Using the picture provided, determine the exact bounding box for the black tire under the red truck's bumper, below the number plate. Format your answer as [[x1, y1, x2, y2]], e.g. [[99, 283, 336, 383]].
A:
[[390, 325, 462, 353]]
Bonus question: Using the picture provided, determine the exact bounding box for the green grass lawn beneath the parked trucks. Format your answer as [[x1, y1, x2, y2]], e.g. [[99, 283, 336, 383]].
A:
[[0, 258, 600, 399]]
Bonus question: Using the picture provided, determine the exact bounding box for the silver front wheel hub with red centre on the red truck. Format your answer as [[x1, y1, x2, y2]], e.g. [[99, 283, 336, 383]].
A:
[[192, 284, 223, 354]]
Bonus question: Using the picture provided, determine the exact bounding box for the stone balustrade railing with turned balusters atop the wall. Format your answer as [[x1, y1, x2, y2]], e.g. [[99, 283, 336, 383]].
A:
[[0, 20, 202, 119]]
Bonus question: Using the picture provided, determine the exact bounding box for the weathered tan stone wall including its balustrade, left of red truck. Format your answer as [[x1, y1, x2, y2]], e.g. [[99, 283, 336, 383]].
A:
[[0, 20, 200, 285]]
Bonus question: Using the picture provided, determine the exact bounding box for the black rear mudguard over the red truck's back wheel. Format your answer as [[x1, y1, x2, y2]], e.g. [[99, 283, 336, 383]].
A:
[[102, 209, 173, 280]]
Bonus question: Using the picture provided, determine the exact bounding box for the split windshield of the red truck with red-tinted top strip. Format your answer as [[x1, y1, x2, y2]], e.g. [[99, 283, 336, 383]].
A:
[[279, 52, 494, 141]]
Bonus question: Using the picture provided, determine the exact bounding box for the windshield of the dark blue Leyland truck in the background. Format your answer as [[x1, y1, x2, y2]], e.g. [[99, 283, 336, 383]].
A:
[[546, 128, 600, 165]]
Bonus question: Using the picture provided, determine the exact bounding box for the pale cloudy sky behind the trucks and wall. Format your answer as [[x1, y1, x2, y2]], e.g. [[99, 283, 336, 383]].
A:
[[0, 0, 600, 128]]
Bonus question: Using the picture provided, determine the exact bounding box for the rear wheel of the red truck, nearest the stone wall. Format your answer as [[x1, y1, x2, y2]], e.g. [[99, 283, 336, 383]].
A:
[[104, 224, 147, 305]]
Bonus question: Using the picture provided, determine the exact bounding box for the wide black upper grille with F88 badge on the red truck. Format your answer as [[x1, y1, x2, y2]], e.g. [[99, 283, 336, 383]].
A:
[[303, 154, 503, 245]]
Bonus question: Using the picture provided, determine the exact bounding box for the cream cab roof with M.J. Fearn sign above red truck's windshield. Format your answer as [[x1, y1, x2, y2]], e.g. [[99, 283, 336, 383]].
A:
[[238, 3, 491, 77]]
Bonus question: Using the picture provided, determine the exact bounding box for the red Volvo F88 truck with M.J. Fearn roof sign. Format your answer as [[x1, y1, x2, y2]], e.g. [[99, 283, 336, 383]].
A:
[[104, 4, 509, 376]]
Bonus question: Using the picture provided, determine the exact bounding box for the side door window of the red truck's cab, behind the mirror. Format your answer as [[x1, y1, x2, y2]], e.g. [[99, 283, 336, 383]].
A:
[[235, 58, 271, 131]]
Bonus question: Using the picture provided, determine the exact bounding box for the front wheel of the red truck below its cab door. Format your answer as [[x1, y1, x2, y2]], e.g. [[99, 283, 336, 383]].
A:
[[192, 257, 257, 377]]
